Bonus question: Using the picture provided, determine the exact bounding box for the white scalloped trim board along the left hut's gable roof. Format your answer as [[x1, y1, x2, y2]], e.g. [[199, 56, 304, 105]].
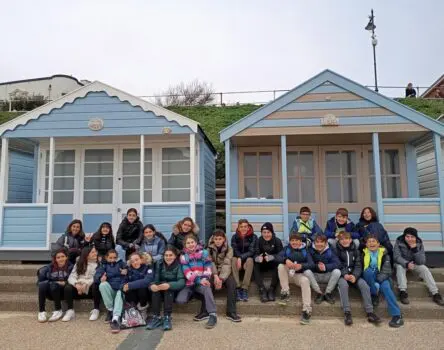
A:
[[0, 81, 199, 135]]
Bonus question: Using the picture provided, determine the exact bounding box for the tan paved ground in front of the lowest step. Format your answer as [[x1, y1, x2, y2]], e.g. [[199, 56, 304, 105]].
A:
[[0, 313, 444, 350]]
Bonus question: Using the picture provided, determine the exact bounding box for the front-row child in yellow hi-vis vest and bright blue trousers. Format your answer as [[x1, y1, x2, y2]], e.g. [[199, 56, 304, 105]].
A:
[[363, 234, 404, 328]]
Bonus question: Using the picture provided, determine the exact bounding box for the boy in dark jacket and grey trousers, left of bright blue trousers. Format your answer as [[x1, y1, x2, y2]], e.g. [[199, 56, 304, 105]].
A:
[[336, 232, 381, 326]]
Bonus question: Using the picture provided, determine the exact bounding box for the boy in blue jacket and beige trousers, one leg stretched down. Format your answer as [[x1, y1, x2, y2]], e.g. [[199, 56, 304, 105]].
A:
[[276, 233, 314, 324]]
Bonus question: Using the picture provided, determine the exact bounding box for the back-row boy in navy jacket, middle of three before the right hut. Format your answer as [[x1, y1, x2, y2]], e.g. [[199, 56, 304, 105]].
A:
[[324, 208, 361, 250]]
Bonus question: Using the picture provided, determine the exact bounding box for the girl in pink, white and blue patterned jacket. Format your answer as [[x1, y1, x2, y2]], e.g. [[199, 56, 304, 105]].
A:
[[176, 234, 217, 329]]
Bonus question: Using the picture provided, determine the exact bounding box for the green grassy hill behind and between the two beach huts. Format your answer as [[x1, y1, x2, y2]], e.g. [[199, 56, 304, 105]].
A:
[[0, 98, 444, 178]]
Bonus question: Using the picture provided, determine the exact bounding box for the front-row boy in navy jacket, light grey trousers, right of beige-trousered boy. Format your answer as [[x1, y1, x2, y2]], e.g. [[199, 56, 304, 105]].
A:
[[304, 235, 341, 304]]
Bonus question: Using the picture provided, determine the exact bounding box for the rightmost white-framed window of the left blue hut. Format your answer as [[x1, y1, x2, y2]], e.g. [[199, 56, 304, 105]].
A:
[[162, 147, 190, 202]]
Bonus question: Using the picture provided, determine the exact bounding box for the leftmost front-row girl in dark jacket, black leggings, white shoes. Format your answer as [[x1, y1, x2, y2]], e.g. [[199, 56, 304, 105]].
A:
[[37, 248, 73, 322]]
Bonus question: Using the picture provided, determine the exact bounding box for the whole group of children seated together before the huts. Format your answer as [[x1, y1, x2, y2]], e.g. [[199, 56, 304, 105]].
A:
[[38, 207, 444, 333]]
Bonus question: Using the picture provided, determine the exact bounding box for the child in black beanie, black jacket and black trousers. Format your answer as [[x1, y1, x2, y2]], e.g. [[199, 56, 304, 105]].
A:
[[254, 222, 284, 303]]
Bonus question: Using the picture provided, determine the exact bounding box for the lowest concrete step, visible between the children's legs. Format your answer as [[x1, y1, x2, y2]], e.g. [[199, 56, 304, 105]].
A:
[[0, 293, 444, 322]]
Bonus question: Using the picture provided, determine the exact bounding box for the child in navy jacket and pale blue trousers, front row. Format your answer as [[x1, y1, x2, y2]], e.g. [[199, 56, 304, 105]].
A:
[[94, 249, 128, 333]]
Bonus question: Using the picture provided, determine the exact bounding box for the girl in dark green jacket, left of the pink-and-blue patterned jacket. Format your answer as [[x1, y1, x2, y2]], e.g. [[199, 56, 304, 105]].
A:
[[146, 246, 185, 331]]
